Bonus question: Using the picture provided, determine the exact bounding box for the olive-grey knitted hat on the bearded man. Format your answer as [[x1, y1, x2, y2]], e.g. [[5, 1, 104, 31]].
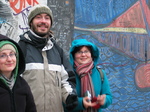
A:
[[28, 4, 53, 26]]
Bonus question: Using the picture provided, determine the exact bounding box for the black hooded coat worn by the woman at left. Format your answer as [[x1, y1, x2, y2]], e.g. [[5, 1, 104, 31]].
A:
[[0, 34, 36, 112]]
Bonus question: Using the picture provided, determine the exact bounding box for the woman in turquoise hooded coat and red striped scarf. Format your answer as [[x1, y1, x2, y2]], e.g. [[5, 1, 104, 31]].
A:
[[64, 39, 112, 112]]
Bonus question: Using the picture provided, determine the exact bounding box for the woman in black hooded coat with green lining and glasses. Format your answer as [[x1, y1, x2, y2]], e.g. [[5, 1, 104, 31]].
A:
[[0, 34, 36, 112]]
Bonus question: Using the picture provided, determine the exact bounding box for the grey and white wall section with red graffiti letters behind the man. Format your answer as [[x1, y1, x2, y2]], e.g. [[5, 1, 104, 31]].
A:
[[0, 0, 75, 53]]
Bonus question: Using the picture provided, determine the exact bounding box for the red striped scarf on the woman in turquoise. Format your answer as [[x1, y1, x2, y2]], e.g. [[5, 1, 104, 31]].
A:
[[74, 61, 96, 112]]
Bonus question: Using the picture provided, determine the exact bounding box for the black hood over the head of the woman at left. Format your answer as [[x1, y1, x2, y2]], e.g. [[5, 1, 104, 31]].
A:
[[0, 34, 25, 75]]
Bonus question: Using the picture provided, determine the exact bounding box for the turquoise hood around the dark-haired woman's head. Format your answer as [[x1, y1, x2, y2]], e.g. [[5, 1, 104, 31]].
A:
[[70, 39, 99, 66]]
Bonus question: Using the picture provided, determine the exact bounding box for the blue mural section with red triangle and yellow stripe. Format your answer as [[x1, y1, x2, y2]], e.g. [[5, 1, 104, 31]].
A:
[[73, 0, 150, 112]]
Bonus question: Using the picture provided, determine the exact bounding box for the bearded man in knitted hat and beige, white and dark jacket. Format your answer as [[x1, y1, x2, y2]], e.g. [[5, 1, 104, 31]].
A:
[[19, 4, 77, 112]]
